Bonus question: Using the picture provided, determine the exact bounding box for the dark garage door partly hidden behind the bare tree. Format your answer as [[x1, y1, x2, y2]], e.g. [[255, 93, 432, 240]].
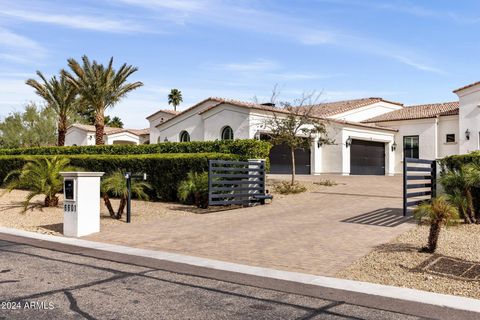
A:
[[270, 144, 310, 174]]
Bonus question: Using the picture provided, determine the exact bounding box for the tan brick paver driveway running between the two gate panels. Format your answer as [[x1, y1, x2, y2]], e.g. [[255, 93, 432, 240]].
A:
[[86, 176, 414, 275]]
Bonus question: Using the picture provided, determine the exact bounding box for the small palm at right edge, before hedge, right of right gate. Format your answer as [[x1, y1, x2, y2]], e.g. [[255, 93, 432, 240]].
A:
[[440, 164, 480, 223]]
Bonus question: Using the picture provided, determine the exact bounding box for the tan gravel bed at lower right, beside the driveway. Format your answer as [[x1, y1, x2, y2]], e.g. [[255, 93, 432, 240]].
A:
[[336, 225, 480, 299]]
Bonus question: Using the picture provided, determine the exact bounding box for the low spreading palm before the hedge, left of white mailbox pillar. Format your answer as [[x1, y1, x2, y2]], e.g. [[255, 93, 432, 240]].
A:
[[4, 156, 73, 212]]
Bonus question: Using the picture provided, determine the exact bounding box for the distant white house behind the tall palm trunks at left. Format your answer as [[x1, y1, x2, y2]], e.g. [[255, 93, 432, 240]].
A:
[[65, 123, 150, 146]]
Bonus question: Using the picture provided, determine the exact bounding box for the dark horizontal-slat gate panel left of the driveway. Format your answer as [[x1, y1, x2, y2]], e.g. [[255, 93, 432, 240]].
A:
[[208, 160, 266, 206]]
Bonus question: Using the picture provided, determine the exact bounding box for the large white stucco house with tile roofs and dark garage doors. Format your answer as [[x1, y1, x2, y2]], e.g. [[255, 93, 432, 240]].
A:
[[147, 82, 480, 175]]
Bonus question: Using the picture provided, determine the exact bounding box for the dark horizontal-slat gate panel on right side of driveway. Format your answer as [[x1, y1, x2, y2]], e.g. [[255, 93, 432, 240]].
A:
[[403, 158, 437, 216]]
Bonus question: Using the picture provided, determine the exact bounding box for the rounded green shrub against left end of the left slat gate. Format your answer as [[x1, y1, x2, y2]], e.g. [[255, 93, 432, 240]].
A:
[[178, 172, 208, 208]]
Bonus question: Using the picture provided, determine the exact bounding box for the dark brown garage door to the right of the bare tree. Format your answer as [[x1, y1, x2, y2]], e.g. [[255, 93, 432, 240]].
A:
[[350, 140, 385, 175]]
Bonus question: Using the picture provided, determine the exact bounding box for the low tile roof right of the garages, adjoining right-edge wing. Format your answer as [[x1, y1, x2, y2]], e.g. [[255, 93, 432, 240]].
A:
[[363, 101, 459, 123]]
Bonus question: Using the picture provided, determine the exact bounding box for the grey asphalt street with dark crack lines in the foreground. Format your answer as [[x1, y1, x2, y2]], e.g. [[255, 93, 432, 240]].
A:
[[0, 236, 472, 320]]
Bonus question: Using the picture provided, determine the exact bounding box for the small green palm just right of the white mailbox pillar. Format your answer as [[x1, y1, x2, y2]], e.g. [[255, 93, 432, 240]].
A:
[[101, 171, 152, 220]]
